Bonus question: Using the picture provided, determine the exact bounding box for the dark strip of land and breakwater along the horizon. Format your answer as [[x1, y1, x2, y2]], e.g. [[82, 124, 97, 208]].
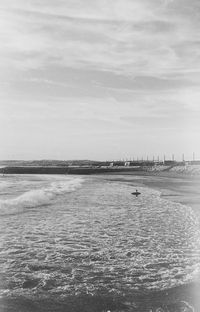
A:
[[0, 160, 200, 177]]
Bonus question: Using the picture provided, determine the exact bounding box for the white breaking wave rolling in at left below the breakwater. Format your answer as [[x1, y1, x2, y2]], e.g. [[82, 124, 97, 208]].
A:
[[0, 178, 83, 215]]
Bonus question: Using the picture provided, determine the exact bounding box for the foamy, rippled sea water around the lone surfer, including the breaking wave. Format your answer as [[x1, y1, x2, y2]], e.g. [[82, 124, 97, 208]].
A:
[[0, 175, 200, 312]]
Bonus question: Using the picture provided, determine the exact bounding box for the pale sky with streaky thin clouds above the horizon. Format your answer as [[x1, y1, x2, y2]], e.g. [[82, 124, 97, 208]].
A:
[[0, 0, 200, 160]]
